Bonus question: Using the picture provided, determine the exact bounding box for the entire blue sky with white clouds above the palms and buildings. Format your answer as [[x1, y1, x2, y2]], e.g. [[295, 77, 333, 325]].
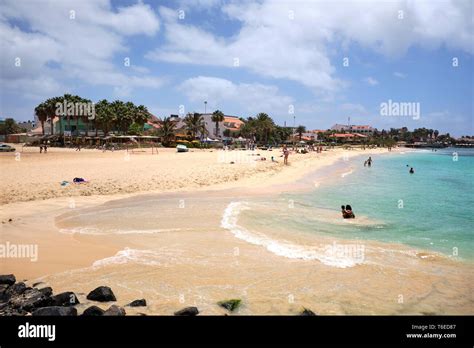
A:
[[0, 0, 474, 136]]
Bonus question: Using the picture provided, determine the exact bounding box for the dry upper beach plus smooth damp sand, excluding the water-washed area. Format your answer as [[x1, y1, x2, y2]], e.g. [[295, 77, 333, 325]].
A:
[[0, 146, 387, 278]]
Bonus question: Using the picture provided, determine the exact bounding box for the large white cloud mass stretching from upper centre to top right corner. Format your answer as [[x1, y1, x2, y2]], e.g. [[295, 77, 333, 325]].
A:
[[147, 0, 474, 93]]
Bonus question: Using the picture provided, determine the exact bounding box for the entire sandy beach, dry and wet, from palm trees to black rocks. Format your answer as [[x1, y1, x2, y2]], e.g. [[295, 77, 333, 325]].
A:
[[0, 145, 472, 315]]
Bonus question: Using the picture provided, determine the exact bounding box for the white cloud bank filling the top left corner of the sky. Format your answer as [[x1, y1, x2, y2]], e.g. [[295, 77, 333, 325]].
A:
[[0, 0, 162, 98]]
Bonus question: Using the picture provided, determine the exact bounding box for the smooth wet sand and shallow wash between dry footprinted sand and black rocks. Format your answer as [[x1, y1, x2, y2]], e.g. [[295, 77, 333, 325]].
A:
[[0, 145, 471, 315]]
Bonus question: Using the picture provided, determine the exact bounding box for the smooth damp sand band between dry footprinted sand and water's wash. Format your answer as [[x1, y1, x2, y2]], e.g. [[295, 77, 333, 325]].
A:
[[0, 149, 396, 278]]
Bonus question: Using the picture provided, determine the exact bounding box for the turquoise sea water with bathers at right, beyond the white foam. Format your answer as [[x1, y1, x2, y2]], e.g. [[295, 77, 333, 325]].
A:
[[239, 148, 474, 260]]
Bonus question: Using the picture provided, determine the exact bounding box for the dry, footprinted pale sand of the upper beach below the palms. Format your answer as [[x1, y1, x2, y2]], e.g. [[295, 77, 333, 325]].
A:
[[0, 146, 387, 204]]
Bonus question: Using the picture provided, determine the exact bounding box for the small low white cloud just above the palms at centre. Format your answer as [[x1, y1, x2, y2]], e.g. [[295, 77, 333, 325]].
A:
[[178, 76, 293, 114]]
